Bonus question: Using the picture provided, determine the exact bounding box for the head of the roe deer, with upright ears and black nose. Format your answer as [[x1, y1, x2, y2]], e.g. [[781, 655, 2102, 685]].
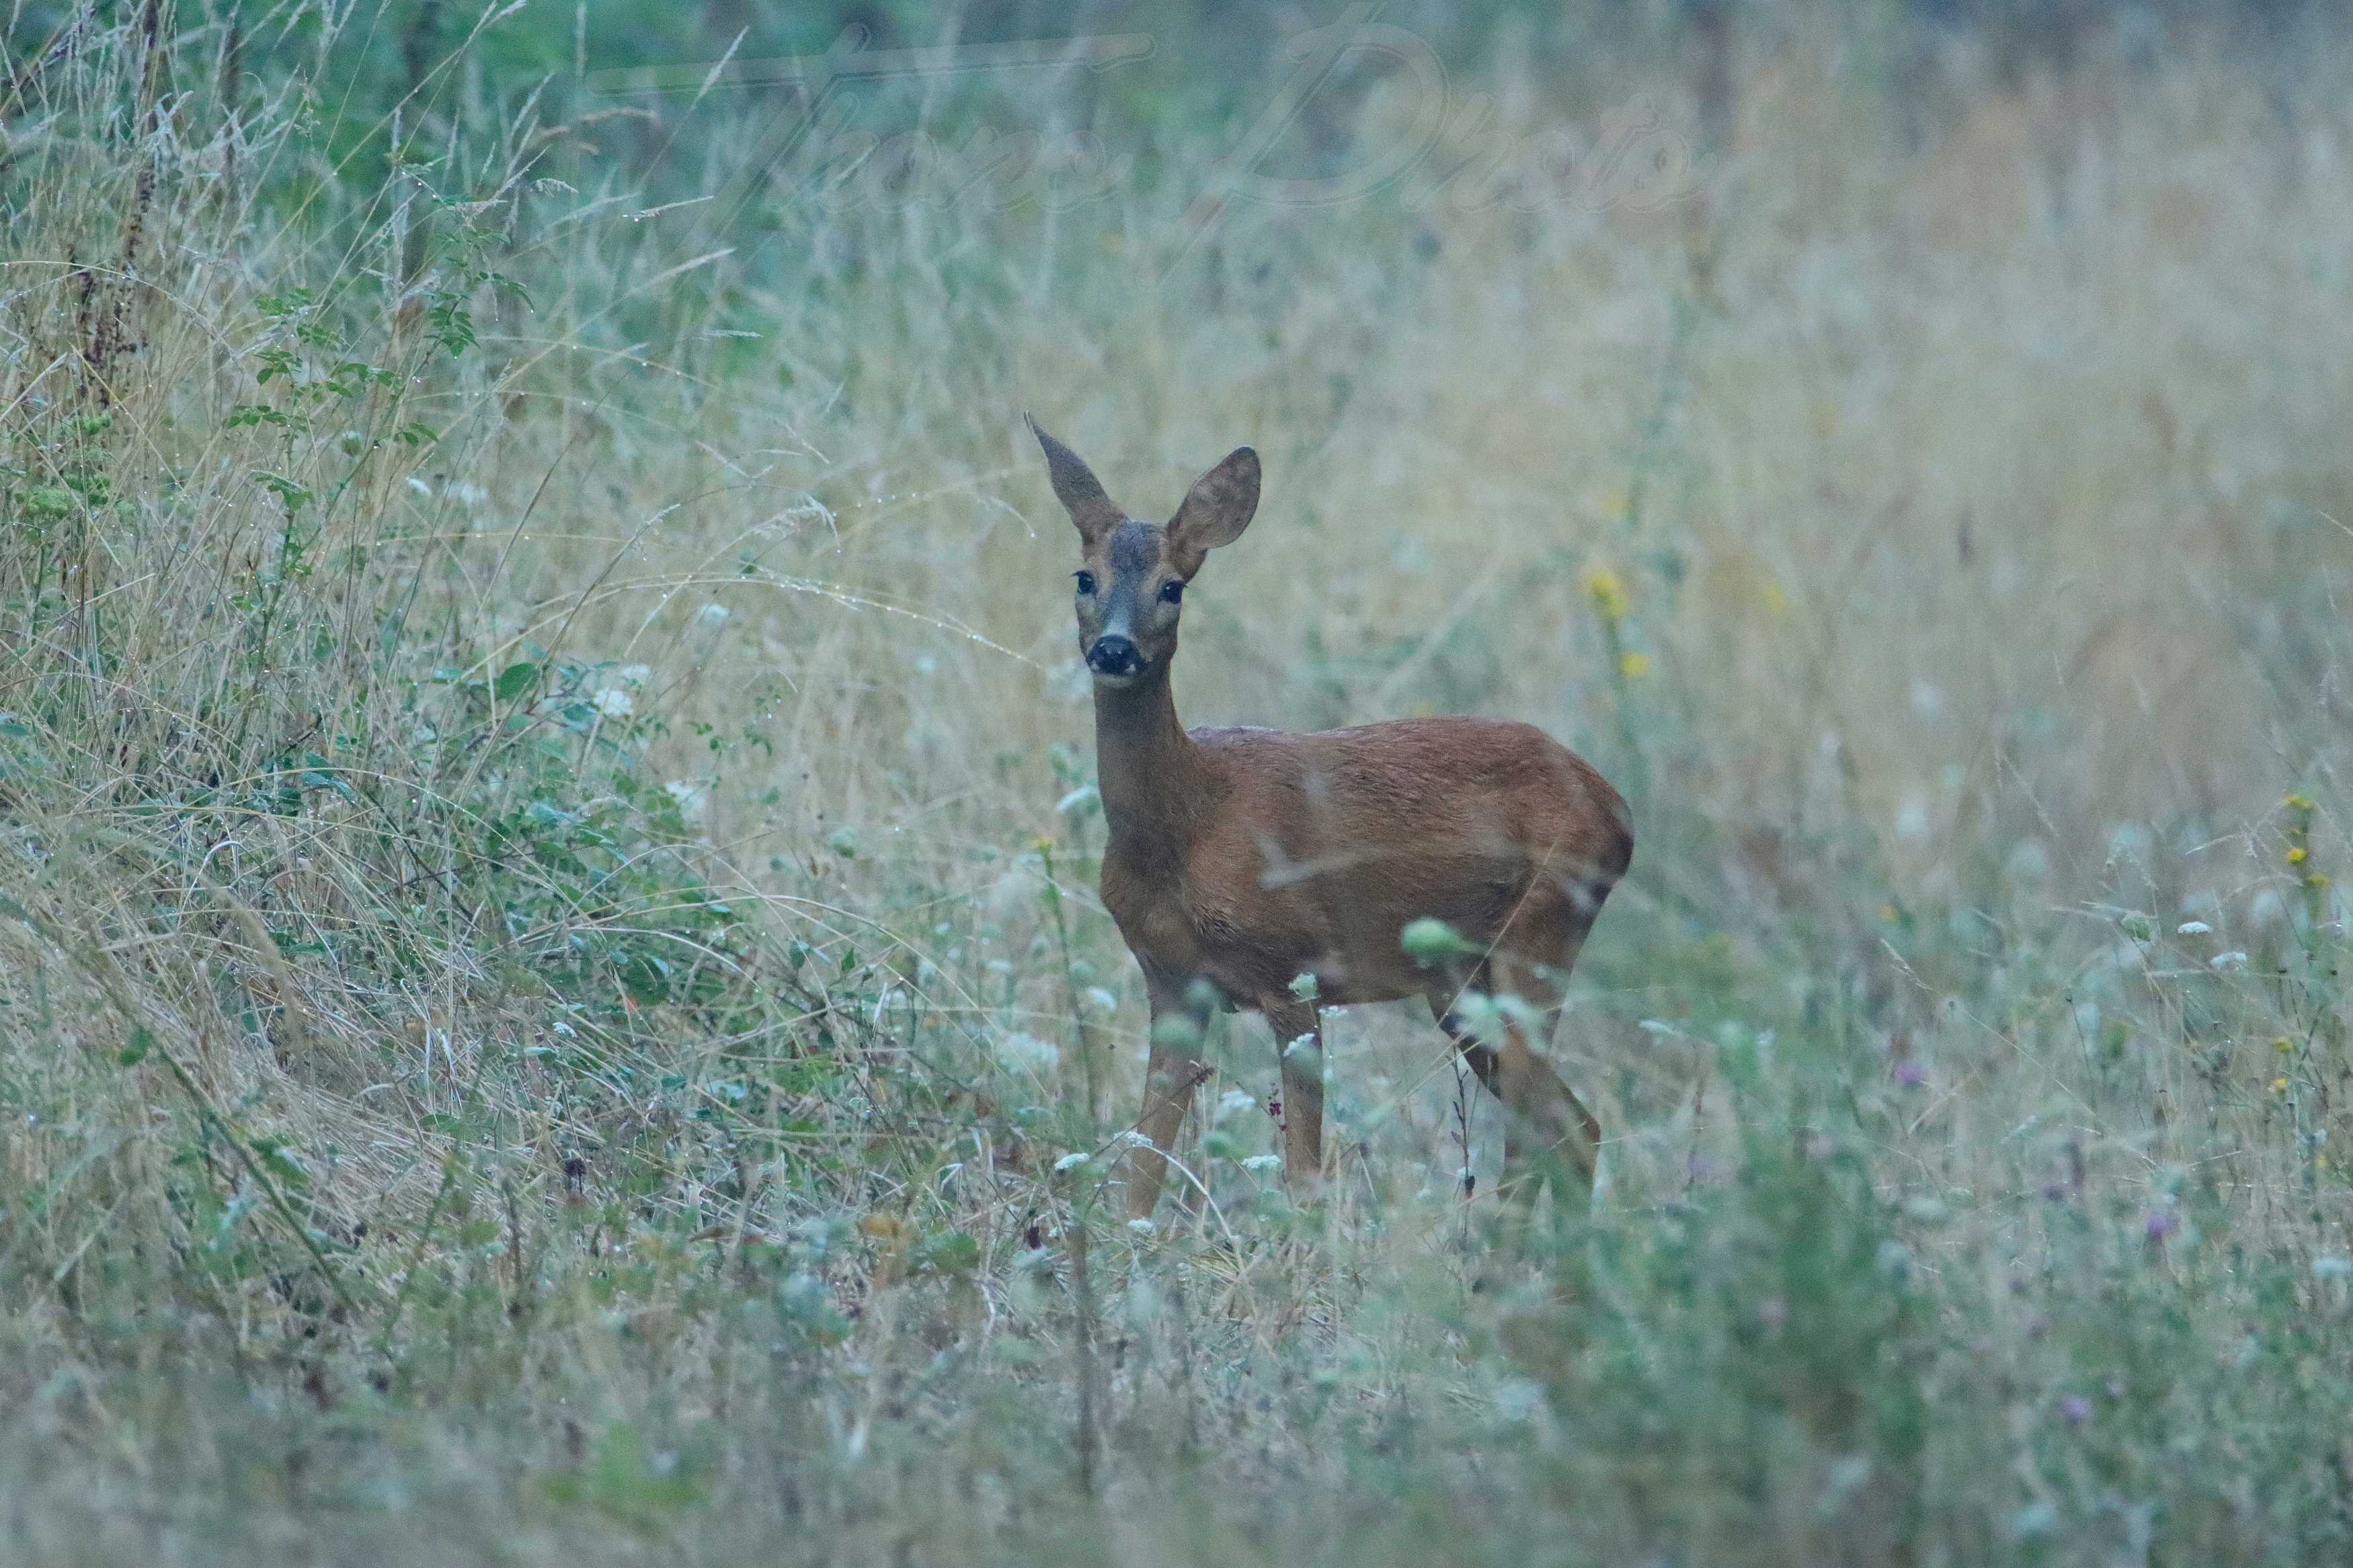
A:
[[1029, 419, 1259, 686]]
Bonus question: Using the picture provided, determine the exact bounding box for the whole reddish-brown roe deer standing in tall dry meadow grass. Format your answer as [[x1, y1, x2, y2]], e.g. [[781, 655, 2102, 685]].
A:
[[1031, 421, 1633, 1218]]
